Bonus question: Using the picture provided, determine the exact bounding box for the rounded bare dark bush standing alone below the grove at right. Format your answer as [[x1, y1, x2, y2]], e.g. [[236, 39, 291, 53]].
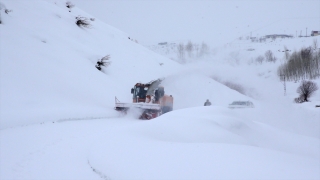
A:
[[297, 80, 318, 102]]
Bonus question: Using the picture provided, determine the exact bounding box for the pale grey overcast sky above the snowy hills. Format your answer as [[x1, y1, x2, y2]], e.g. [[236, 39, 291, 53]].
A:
[[72, 0, 320, 44]]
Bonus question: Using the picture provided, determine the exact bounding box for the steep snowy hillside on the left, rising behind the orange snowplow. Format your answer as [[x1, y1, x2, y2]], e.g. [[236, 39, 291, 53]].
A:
[[1, 1, 179, 128]]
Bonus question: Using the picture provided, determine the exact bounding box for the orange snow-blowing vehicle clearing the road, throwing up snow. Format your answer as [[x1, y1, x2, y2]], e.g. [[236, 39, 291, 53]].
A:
[[114, 79, 173, 120]]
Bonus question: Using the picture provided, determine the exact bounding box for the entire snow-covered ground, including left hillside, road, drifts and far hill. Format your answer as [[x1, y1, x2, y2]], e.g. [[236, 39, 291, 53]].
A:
[[0, 0, 320, 180]]
